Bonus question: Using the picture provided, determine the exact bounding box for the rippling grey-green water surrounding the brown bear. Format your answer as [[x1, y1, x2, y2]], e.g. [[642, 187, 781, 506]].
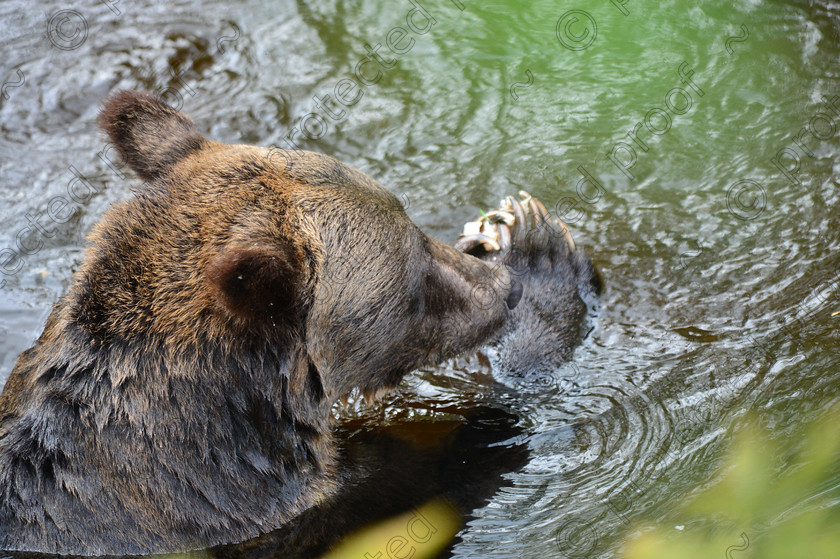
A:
[[0, 0, 840, 557]]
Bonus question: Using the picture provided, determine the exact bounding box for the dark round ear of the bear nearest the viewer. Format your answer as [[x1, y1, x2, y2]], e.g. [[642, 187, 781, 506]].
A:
[[207, 246, 304, 321]]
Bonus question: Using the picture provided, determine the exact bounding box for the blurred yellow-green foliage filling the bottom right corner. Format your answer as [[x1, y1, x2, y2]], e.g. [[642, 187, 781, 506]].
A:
[[622, 409, 840, 559]]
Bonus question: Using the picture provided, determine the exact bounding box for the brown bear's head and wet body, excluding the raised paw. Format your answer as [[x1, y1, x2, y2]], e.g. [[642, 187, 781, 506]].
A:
[[0, 91, 521, 555]]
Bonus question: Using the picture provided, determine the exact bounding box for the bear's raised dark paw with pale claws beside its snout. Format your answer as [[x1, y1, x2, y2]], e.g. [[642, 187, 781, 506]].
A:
[[455, 191, 601, 382]]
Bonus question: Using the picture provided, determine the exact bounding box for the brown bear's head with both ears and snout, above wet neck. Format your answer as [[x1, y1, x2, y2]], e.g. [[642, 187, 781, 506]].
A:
[[93, 92, 518, 412]]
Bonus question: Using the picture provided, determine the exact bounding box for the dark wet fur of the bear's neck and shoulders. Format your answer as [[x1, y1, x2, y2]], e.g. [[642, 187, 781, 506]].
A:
[[0, 309, 335, 554]]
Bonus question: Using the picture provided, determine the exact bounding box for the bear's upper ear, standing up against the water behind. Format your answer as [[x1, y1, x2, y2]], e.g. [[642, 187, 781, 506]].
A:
[[99, 91, 209, 181]]
